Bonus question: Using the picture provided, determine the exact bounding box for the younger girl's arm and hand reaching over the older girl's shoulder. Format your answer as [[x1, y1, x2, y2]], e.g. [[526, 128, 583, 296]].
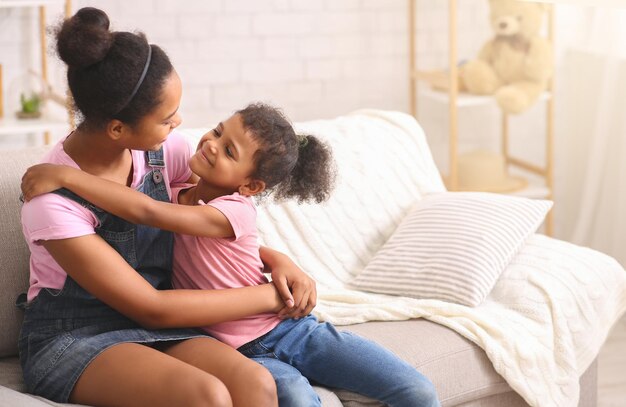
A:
[[22, 164, 234, 237]]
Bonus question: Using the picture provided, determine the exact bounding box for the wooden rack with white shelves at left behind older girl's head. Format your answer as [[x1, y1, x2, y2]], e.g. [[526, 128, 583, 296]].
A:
[[0, 0, 73, 144]]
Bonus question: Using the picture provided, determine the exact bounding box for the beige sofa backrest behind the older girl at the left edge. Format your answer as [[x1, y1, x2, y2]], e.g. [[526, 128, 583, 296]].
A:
[[0, 147, 49, 357]]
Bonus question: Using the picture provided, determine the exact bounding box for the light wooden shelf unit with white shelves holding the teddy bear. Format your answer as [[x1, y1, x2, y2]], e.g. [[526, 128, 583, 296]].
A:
[[408, 0, 554, 236]]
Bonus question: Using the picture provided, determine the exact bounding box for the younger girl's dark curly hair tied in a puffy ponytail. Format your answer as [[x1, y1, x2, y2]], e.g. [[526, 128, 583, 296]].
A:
[[235, 103, 336, 203]]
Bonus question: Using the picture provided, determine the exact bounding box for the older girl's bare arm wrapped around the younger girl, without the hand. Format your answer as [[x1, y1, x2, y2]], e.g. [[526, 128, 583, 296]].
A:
[[43, 234, 284, 328]]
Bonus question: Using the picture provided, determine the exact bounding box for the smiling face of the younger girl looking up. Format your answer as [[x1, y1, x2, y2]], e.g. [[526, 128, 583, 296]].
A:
[[189, 114, 264, 196]]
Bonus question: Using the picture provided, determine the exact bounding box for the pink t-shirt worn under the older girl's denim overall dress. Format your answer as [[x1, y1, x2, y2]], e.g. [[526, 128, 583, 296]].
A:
[[22, 132, 191, 301]]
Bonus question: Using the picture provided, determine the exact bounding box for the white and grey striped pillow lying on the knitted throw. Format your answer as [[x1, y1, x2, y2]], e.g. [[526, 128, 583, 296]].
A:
[[352, 192, 552, 307]]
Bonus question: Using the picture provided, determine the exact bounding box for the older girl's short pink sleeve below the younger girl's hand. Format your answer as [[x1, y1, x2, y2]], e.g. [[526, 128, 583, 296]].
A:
[[22, 193, 98, 243]]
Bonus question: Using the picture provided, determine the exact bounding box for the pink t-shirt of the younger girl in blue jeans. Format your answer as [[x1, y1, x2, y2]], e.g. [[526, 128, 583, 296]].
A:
[[172, 190, 281, 348]]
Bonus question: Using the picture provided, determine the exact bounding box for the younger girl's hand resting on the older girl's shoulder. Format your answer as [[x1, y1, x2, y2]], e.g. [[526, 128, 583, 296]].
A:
[[21, 164, 73, 202]]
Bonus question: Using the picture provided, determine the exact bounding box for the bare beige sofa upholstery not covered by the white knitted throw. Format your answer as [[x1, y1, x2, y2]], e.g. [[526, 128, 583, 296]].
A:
[[0, 142, 596, 407]]
